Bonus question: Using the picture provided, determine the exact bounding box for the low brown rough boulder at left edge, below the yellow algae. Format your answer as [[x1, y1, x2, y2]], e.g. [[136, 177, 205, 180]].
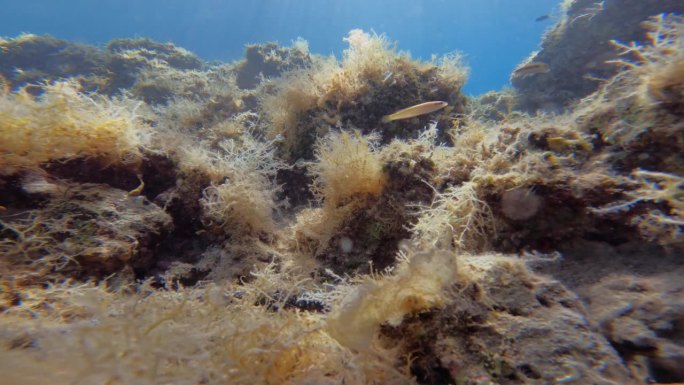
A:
[[0, 175, 173, 285]]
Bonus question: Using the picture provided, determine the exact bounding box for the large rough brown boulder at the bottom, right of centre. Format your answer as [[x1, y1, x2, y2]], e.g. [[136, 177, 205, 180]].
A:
[[382, 255, 635, 385]]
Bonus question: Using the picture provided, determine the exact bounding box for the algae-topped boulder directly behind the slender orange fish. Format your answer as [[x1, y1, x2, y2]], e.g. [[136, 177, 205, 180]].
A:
[[259, 30, 468, 161]]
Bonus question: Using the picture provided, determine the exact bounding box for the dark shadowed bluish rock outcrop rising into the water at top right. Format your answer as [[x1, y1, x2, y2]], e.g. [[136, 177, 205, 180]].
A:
[[511, 0, 684, 113]]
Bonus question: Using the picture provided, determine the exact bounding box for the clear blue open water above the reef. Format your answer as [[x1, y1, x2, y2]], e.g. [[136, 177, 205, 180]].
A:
[[0, 0, 558, 94]]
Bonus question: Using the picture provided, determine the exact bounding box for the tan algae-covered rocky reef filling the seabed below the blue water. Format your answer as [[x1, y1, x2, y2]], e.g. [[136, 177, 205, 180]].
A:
[[0, 1, 684, 385]]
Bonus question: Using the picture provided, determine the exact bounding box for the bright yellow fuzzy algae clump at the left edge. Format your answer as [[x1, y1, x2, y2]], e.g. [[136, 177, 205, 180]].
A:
[[0, 82, 148, 175]]
